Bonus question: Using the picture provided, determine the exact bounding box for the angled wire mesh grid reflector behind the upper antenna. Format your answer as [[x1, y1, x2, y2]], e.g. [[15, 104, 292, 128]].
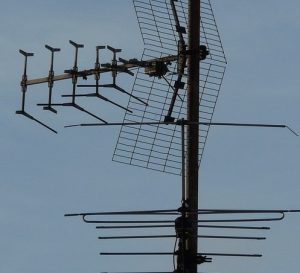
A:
[[113, 0, 226, 175]]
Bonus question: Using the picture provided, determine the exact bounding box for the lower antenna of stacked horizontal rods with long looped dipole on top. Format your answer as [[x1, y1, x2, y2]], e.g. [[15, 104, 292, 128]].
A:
[[65, 205, 300, 272]]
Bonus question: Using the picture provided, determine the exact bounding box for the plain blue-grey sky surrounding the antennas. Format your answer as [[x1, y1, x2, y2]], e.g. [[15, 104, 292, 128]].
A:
[[0, 0, 300, 273]]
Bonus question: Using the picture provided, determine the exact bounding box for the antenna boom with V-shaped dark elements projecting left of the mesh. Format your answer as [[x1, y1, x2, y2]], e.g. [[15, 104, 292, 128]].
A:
[[16, 40, 152, 133]]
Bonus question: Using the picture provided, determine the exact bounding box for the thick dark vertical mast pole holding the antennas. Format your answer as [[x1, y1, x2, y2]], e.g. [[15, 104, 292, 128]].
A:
[[185, 0, 200, 273]]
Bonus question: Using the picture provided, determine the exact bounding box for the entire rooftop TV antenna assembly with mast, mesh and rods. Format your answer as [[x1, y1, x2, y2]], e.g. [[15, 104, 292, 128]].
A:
[[17, 0, 299, 273]]
